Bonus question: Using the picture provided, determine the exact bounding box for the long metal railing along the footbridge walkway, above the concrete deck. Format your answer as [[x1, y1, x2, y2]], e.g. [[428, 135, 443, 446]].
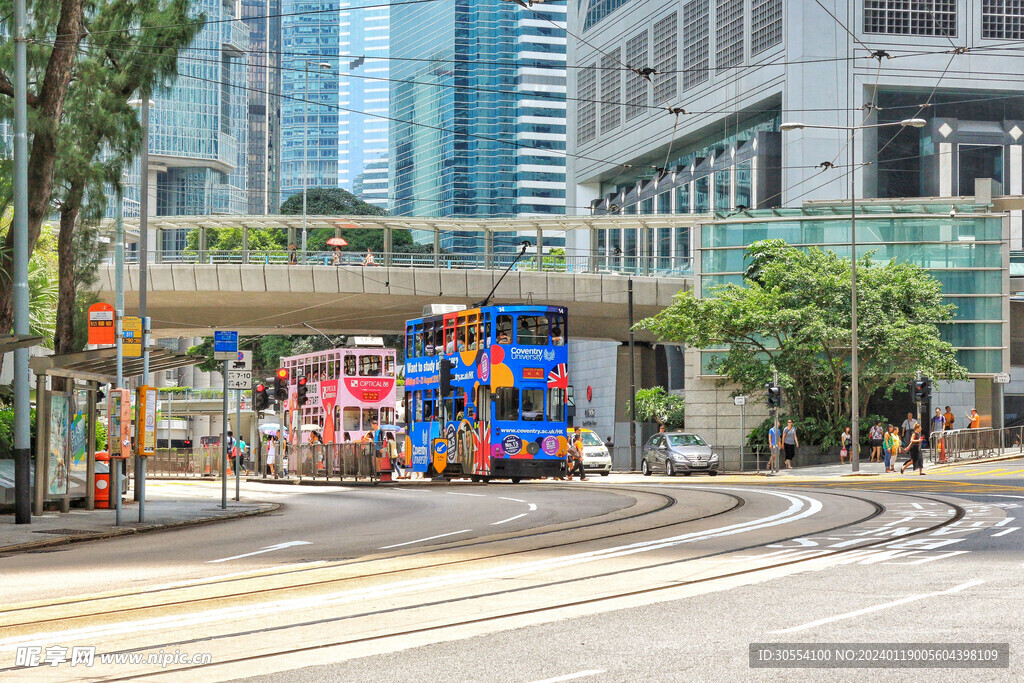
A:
[[117, 250, 693, 276]]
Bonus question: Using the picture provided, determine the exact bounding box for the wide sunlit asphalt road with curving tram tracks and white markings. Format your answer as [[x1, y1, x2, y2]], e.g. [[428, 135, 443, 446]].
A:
[[0, 461, 1024, 682]]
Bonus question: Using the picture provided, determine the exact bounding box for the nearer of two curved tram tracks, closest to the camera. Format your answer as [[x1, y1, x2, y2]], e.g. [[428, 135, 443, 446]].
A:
[[0, 489, 966, 680]]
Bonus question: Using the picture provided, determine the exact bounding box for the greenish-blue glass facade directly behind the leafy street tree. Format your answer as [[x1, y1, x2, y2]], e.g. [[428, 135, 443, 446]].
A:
[[697, 201, 1010, 376]]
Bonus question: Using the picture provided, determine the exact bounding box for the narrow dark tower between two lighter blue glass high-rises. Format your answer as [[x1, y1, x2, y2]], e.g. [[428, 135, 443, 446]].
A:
[[242, 0, 281, 214]]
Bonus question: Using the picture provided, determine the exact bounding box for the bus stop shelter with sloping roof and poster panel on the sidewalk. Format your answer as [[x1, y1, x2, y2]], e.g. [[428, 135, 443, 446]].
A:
[[29, 346, 206, 515]]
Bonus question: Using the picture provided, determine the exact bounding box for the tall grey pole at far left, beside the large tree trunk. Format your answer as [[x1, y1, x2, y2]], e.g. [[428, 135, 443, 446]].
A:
[[12, 0, 31, 524]]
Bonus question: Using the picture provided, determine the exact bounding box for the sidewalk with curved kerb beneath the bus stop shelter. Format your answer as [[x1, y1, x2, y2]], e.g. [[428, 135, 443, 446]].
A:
[[0, 498, 281, 556]]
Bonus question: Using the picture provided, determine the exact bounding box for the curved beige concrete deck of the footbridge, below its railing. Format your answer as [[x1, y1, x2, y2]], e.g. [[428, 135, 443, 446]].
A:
[[96, 262, 692, 341]]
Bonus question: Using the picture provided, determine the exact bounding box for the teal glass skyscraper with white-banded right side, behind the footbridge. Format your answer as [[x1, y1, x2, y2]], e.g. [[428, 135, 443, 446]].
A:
[[389, 0, 565, 217]]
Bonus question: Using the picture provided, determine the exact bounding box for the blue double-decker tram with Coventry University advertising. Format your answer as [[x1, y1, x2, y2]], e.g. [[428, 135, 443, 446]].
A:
[[406, 305, 568, 481]]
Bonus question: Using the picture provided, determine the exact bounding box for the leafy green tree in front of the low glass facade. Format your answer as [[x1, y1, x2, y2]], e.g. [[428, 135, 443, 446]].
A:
[[637, 240, 968, 440]]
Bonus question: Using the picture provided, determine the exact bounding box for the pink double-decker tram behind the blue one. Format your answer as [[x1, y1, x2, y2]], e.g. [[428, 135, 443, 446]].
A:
[[281, 337, 397, 443]]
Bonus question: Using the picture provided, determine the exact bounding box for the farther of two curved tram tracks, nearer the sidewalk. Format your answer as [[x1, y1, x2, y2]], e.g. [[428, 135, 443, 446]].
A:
[[0, 487, 745, 630]]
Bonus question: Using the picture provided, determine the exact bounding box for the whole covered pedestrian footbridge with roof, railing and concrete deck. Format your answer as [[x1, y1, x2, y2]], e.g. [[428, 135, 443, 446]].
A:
[[96, 216, 700, 340]]
